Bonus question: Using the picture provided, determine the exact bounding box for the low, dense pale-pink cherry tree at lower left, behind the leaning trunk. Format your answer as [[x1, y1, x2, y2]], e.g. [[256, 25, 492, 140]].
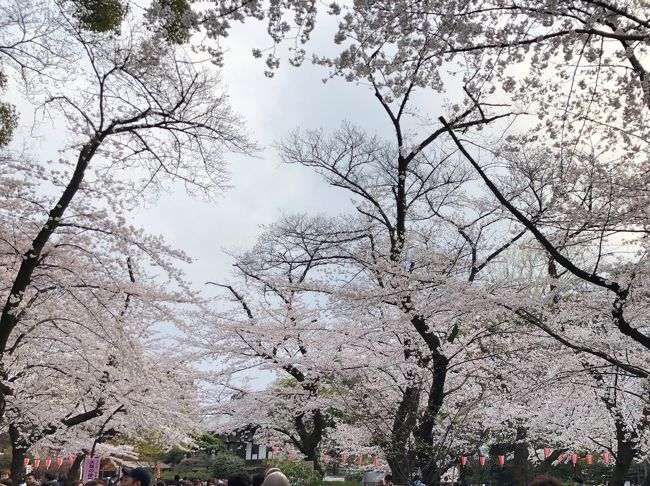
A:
[[0, 166, 198, 473]]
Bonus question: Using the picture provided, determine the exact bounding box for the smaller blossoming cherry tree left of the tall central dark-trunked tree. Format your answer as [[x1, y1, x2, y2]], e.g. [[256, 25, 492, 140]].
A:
[[193, 215, 362, 470]]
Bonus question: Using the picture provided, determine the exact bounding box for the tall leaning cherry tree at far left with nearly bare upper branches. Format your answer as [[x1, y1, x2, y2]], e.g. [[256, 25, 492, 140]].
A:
[[0, 0, 254, 430]]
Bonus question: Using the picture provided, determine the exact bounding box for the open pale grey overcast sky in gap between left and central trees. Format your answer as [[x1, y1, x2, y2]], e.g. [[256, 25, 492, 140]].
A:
[[136, 15, 446, 294]]
